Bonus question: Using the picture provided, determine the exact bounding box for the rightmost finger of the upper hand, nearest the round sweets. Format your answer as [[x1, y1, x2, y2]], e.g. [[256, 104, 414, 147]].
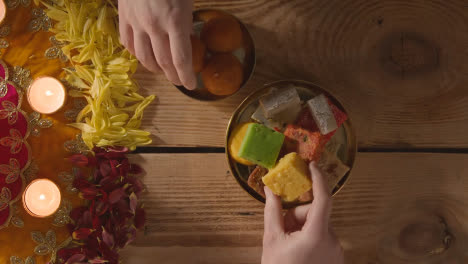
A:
[[169, 28, 197, 90]]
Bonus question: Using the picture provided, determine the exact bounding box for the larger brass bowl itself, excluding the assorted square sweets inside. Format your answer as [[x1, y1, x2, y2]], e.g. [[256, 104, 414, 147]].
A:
[[225, 80, 357, 207]]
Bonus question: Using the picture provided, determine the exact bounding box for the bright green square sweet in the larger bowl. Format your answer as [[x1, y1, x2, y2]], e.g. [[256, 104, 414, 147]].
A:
[[239, 124, 284, 169]]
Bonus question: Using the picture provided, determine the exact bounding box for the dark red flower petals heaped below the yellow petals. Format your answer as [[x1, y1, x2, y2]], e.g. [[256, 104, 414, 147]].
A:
[[58, 147, 146, 264]]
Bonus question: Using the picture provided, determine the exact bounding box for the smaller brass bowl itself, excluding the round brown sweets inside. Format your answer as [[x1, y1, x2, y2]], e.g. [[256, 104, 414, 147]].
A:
[[176, 9, 256, 101]]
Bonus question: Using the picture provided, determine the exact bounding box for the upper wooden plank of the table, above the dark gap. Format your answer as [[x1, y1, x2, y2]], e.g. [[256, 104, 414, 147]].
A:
[[136, 0, 468, 148]]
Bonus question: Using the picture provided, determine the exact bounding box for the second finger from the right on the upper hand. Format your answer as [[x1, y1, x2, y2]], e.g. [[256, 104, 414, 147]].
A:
[[151, 33, 182, 85]]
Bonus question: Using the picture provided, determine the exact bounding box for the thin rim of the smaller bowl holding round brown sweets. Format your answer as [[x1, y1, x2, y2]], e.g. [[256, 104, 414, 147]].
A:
[[174, 8, 257, 102]]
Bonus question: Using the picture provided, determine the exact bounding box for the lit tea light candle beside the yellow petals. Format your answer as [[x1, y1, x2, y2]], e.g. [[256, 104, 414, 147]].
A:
[[28, 77, 66, 114]]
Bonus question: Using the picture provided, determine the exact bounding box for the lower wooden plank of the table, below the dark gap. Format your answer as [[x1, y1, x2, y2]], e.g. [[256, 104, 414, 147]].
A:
[[123, 153, 468, 264]]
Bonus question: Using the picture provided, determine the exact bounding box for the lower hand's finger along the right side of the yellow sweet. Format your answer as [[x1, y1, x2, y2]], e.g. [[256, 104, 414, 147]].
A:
[[304, 162, 331, 231]]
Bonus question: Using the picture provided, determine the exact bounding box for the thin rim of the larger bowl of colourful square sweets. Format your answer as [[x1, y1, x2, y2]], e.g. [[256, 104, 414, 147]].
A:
[[224, 79, 357, 208]]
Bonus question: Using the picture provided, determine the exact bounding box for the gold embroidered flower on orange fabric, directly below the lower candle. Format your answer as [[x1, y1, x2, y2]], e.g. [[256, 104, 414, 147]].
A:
[[31, 230, 72, 263]]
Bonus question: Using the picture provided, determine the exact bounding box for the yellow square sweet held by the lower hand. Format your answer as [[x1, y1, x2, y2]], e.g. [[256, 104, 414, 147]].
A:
[[262, 152, 312, 202]]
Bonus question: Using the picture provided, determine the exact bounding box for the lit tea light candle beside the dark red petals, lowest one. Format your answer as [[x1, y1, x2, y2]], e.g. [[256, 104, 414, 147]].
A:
[[23, 179, 61, 217]]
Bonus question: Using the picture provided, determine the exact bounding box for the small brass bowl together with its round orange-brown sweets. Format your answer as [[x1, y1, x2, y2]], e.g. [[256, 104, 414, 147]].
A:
[[176, 9, 255, 101]]
